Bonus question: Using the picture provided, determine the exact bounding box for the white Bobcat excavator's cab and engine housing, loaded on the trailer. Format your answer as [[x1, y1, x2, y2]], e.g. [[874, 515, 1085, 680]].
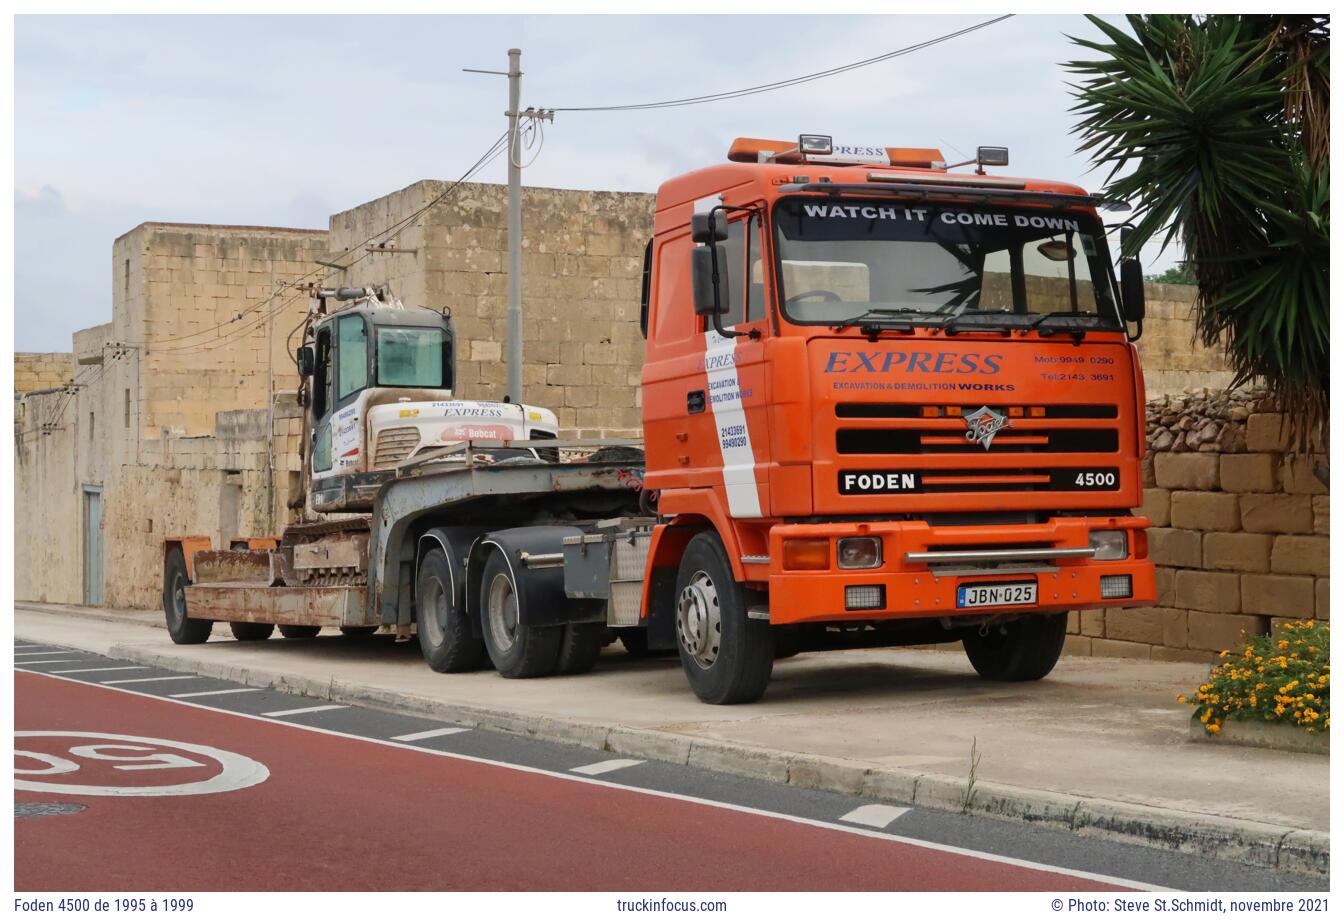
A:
[[298, 287, 556, 512]]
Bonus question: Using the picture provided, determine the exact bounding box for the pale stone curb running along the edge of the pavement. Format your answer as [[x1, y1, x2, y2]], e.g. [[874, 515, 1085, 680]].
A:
[[86, 633, 1331, 876]]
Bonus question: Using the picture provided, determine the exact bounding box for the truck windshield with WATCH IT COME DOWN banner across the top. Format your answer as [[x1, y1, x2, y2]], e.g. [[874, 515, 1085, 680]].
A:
[[774, 199, 1118, 326]]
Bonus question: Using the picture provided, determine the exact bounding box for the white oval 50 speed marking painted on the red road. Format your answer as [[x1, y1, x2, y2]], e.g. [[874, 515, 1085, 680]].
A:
[[13, 732, 270, 795]]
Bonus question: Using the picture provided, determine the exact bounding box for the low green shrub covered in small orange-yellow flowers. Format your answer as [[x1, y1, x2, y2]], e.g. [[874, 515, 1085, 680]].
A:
[[1176, 620, 1331, 735]]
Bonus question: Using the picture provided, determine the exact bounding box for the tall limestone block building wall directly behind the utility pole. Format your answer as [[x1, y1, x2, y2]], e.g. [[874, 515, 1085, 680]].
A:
[[331, 181, 653, 436]]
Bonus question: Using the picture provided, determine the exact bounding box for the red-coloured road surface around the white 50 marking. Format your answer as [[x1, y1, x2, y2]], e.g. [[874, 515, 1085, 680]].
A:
[[15, 673, 1118, 892]]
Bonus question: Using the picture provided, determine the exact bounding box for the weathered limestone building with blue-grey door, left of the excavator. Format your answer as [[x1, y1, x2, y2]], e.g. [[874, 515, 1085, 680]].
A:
[[15, 223, 327, 607]]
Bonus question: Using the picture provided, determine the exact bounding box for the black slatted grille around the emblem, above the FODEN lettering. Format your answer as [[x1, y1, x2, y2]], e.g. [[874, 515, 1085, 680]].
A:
[[836, 403, 1120, 456]]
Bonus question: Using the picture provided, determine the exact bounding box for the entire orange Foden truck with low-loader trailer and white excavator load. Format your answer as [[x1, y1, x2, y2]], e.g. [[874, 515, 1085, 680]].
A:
[[164, 136, 1154, 704]]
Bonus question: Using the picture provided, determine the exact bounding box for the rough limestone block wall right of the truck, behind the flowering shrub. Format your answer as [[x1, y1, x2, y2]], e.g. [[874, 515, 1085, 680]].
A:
[[1066, 391, 1331, 661]]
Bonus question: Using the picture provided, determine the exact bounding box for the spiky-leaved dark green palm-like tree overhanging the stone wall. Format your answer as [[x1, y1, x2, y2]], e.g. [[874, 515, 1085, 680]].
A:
[[1066, 15, 1331, 449]]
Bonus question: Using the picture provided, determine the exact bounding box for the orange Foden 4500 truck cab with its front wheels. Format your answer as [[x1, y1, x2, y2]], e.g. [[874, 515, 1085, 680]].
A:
[[642, 136, 1154, 701]]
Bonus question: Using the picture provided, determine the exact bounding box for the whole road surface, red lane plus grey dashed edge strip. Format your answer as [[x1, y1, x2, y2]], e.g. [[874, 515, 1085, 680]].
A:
[[15, 639, 1328, 892]]
